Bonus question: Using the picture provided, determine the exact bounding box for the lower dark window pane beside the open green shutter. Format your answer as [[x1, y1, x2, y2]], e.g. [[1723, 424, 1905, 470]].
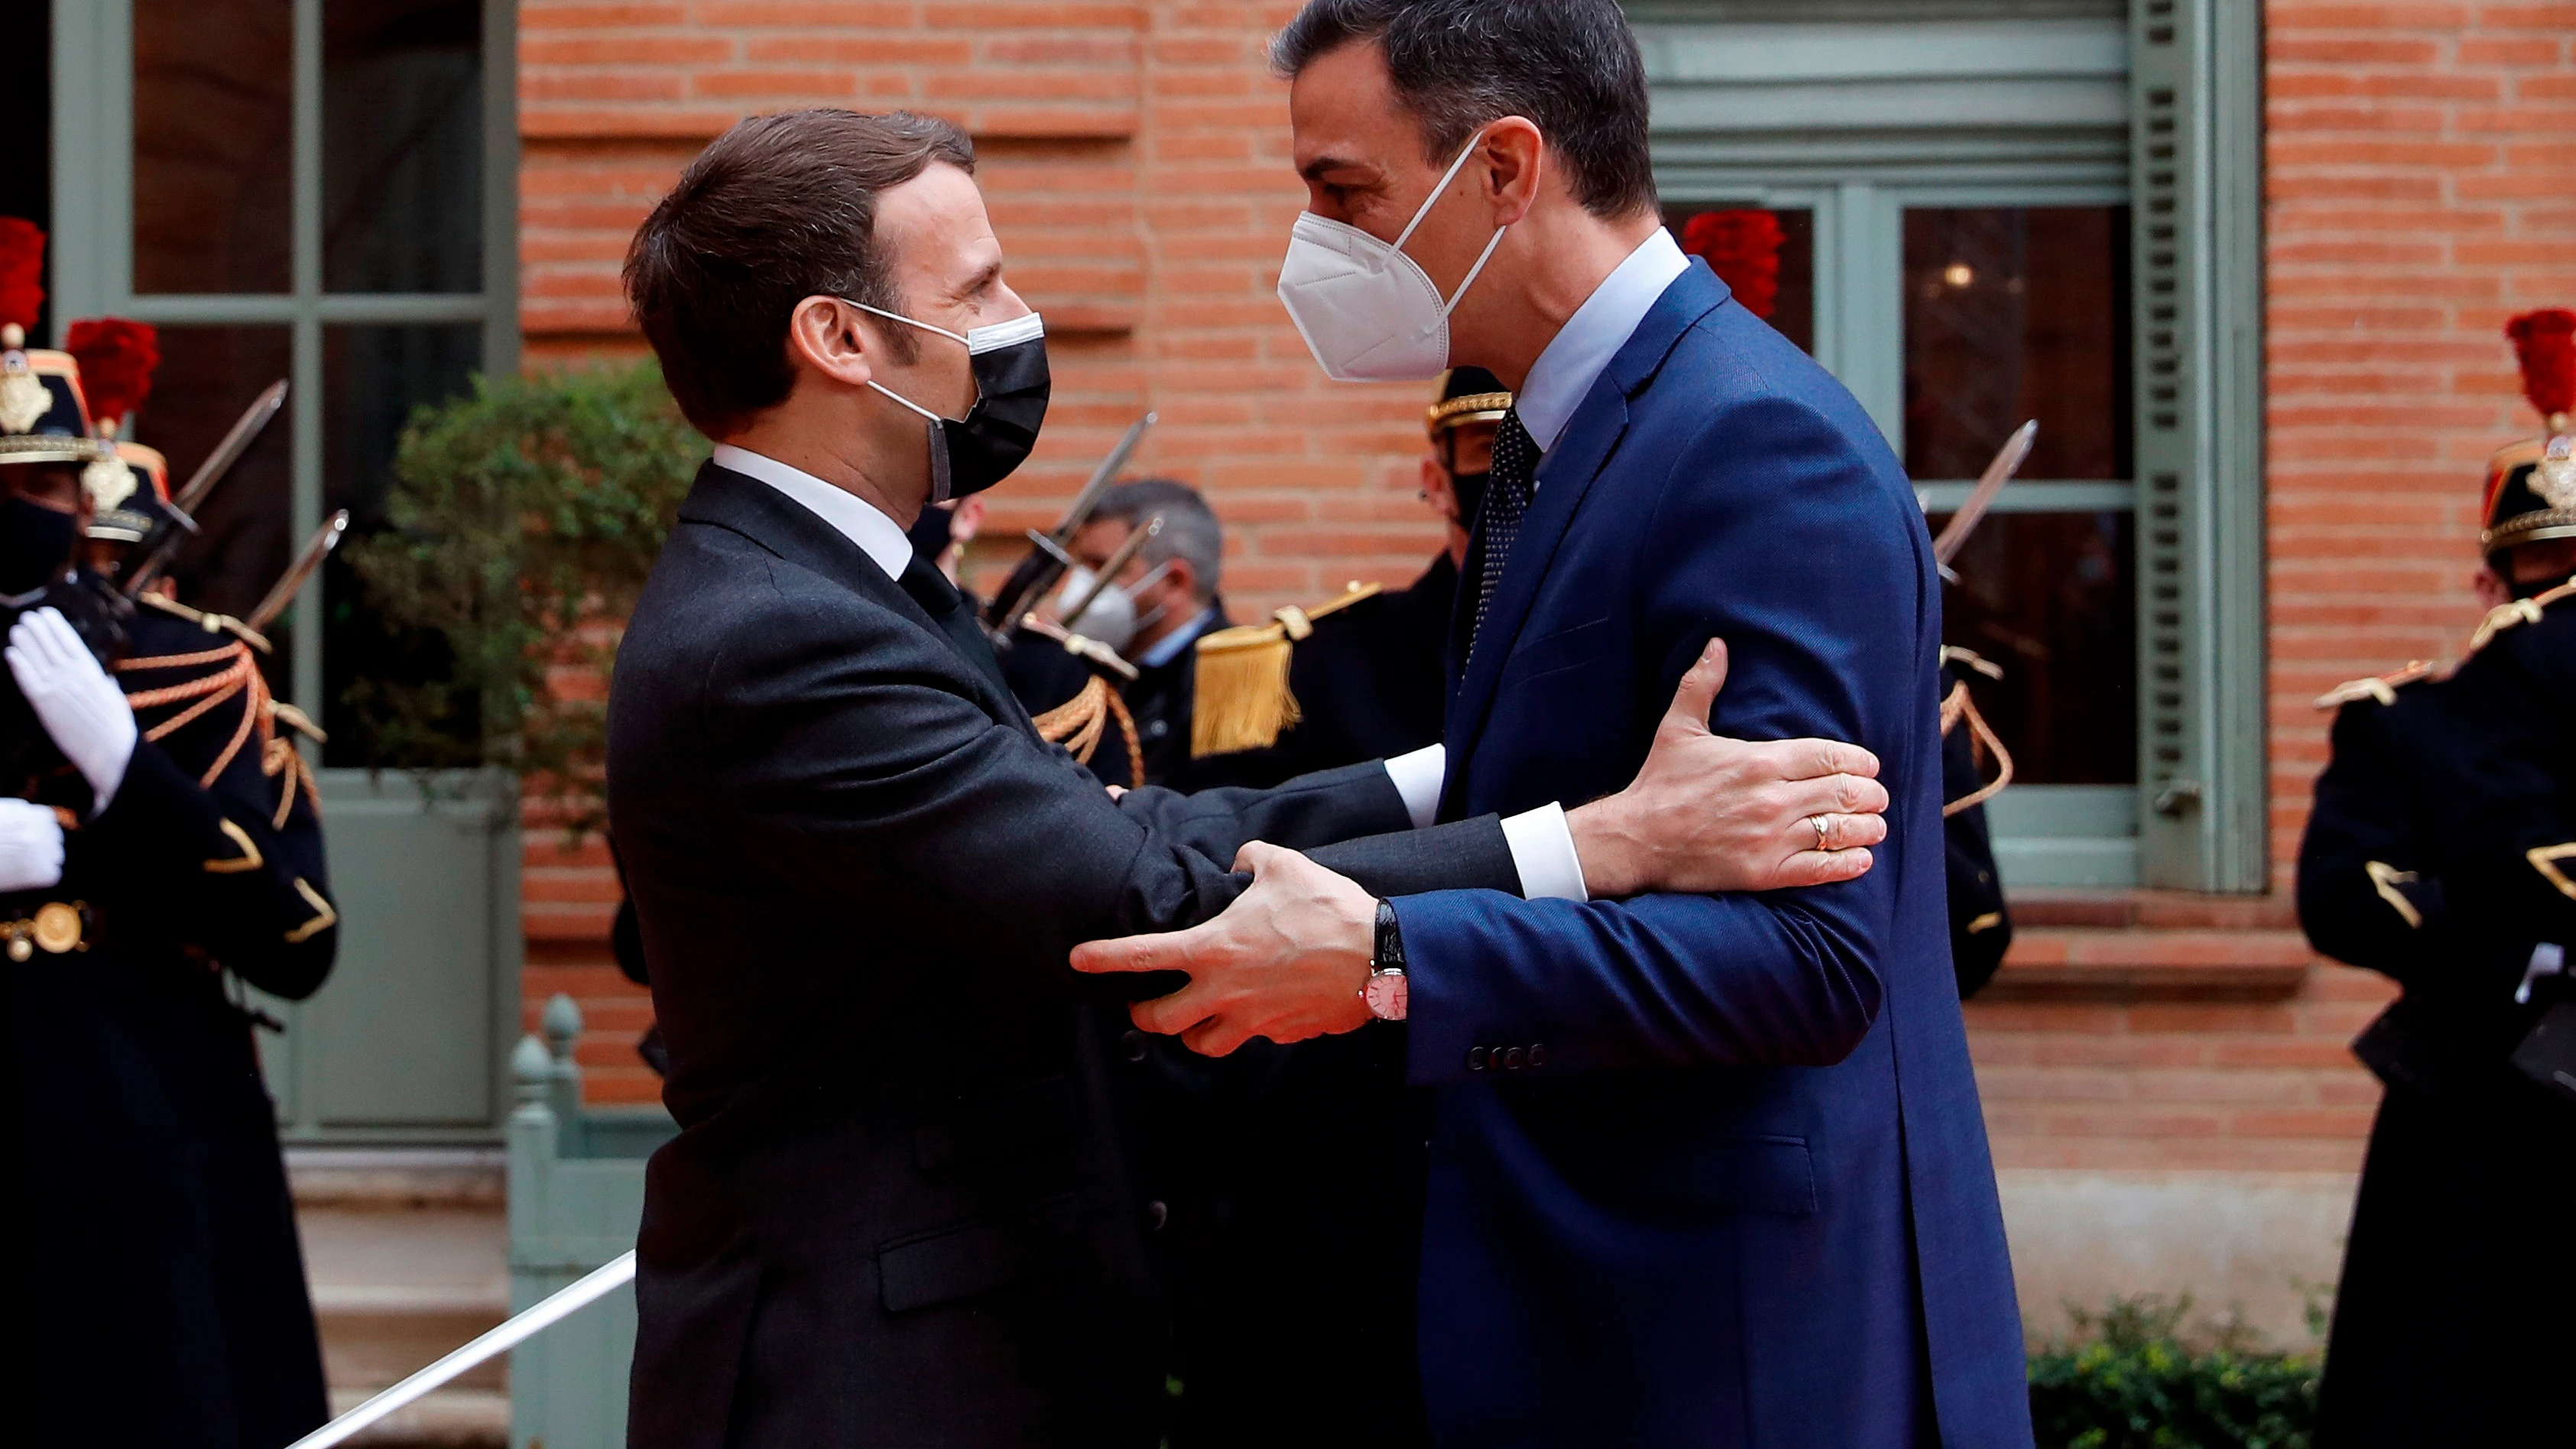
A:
[[1932, 512, 2138, 785]]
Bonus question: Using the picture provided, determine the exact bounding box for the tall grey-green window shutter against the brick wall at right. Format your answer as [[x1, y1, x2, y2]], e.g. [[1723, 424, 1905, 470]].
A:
[[2130, 0, 2267, 890]]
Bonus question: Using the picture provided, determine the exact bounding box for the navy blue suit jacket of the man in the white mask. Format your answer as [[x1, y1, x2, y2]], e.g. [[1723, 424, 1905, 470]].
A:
[[1397, 263, 2030, 1449]]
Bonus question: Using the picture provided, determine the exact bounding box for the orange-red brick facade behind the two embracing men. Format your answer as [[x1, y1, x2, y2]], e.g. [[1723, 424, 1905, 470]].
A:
[[502, 0, 2576, 1235]]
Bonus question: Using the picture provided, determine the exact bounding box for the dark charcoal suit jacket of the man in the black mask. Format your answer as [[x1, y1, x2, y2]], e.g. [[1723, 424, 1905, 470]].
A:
[[608, 466, 1517, 1449]]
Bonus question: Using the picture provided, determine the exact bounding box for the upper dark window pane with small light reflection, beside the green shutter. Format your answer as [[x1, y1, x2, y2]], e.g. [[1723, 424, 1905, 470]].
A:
[[1906, 206, 2130, 481]]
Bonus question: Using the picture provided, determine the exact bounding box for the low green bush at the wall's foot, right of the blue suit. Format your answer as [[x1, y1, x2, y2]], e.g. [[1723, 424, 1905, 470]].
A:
[[2030, 1295, 2318, 1449]]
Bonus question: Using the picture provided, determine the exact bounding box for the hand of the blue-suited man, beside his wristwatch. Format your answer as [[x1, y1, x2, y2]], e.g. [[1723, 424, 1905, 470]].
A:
[[1074, 841, 1378, 1058]]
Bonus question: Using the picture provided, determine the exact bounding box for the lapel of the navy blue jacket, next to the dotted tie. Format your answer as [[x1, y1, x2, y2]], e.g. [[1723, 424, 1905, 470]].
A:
[[1440, 258, 1728, 819]]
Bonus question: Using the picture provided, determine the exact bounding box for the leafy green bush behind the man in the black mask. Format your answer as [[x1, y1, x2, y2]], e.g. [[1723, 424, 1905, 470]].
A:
[[346, 363, 706, 834]]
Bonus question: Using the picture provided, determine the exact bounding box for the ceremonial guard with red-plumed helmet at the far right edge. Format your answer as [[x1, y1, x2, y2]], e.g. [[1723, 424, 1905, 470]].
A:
[[2298, 311, 2576, 1449]]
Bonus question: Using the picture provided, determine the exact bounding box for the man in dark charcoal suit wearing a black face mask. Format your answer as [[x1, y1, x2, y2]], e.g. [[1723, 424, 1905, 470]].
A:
[[608, 111, 1883, 1449]]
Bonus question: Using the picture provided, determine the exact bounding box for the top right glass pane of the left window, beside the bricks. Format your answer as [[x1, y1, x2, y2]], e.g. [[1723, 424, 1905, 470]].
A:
[[322, 0, 482, 291]]
